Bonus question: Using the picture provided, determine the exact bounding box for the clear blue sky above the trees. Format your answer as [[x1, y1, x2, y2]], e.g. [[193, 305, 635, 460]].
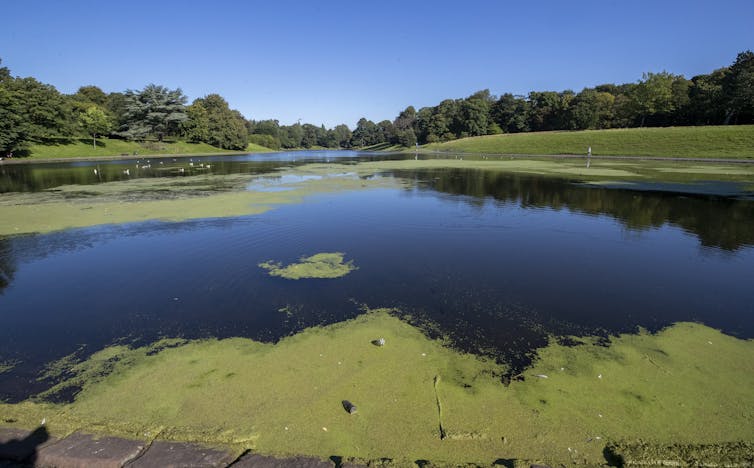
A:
[[0, 0, 754, 128]]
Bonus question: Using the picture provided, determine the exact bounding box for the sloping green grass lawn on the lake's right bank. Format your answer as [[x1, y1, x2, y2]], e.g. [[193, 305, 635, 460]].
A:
[[422, 125, 754, 159]]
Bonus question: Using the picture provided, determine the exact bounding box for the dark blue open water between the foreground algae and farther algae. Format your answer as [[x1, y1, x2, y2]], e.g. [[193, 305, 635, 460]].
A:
[[0, 154, 754, 401]]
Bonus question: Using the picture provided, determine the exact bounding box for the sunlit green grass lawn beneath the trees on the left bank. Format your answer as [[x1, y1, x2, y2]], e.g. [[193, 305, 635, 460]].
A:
[[22, 138, 272, 159]]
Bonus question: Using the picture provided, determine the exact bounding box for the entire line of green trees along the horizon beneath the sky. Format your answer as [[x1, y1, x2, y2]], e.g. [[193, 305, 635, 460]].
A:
[[0, 50, 754, 155]]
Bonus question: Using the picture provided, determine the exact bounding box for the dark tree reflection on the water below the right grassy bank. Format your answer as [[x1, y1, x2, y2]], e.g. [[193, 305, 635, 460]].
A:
[[393, 169, 754, 250]]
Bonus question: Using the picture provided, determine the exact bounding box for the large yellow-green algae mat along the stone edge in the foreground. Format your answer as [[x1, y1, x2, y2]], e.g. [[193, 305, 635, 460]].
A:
[[0, 310, 754, 464]]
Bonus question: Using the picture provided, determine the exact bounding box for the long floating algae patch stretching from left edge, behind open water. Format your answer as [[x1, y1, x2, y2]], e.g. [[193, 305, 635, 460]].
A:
[[0, 168, 396, 235]]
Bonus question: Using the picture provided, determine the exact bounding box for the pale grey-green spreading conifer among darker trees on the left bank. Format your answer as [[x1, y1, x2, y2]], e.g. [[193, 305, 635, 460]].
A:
[[119, 84, 188, 141]]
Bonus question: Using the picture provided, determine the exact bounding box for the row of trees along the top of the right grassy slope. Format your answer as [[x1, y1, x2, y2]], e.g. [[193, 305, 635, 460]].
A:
[[352, 50, 754, 146]]
